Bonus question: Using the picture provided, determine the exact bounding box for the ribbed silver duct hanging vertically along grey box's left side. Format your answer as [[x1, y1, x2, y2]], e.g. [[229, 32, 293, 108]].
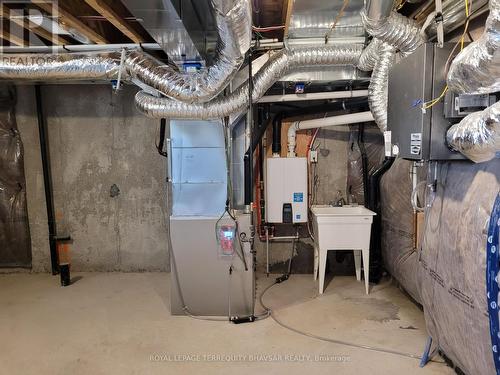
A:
[[368, 43, 396, 132]]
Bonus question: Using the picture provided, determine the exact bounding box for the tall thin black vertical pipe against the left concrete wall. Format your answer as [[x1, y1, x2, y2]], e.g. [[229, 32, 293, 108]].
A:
[[35, 85, 59, 275]]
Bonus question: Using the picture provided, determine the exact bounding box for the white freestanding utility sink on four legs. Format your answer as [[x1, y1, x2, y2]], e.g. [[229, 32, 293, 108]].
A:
[[311, 205, 376, 294]]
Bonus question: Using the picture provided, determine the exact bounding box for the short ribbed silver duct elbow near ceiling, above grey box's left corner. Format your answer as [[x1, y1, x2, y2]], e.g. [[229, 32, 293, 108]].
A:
[[361, 9, 425, 53]]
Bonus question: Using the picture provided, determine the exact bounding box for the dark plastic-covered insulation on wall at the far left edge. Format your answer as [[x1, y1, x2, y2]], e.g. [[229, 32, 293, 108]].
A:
[[0, 86, 31, 267]]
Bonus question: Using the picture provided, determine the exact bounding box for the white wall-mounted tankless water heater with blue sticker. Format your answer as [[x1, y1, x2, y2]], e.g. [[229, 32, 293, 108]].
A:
[[265, 158, 308, 224]]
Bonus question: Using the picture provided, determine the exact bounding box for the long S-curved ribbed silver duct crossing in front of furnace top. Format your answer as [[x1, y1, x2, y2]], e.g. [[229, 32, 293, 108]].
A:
[[135, 45, 362, 119]]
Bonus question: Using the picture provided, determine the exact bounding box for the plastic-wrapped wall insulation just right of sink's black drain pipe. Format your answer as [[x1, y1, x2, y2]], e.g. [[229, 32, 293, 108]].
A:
[[380, 158, 425, 303]]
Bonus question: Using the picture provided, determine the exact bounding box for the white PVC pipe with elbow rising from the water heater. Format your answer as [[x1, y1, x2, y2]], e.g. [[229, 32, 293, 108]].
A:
[[287, 111, 373, 158]]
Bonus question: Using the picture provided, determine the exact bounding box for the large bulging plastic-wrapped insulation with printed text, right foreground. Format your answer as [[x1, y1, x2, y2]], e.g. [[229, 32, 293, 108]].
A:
[[419, 160, 500, 374]]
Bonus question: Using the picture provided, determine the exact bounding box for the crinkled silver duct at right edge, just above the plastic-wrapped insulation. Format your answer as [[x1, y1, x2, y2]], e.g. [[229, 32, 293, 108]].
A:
[[446, 102, 500, 163]]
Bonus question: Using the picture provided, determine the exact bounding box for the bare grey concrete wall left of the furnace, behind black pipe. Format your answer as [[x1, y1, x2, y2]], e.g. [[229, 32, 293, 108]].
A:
[[16, 84, 169, 272]]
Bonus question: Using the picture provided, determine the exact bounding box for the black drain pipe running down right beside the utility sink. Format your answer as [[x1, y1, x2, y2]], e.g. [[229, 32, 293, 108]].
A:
[[368, 157, 394, 283]]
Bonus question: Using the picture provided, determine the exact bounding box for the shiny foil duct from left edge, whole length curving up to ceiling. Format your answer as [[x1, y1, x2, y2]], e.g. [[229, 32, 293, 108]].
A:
[[0, 0, 252, 103]]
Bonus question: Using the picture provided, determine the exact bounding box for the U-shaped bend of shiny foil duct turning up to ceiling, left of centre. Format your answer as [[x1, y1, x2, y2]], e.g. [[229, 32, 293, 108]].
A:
[[125, 0, 252, 103]]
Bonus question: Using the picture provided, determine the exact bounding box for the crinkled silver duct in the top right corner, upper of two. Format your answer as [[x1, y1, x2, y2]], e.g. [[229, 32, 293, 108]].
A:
[[447, 0, 500, 94]]
